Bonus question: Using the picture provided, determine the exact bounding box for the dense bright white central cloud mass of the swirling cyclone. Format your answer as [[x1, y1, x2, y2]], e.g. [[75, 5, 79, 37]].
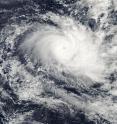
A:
[[21, 17, 104, 81]]
